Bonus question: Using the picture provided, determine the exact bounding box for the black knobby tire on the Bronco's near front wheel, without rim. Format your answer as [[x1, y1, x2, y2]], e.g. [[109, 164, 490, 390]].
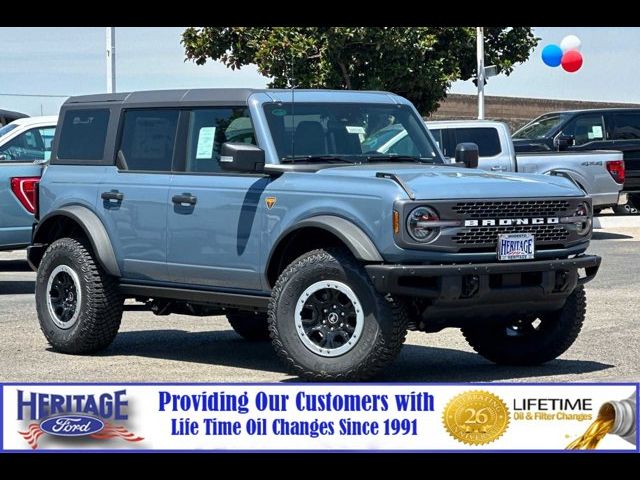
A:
[[269, 248, 408, 381]]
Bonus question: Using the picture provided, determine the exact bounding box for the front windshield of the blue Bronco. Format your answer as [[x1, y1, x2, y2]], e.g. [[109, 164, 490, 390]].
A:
[[264, 102, 442, 163]]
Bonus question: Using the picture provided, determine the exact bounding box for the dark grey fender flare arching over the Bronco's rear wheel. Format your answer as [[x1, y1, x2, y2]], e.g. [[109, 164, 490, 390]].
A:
[[29, 205, 121, 277]]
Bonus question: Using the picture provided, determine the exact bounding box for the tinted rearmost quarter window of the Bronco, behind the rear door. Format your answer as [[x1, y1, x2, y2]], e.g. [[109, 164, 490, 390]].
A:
[[57, 108, 109, 161]]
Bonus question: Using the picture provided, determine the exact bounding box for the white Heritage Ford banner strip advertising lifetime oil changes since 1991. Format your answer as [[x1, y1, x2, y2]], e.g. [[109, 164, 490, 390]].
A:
[[0, 383, 638, 452]]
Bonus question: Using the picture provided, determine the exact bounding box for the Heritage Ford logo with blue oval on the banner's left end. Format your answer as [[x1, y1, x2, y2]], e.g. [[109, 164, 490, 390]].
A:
[[17, 390, 144, 449]]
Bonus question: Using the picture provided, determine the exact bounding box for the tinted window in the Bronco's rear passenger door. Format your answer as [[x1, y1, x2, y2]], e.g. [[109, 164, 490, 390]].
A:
[[119, 109, 179, 172]]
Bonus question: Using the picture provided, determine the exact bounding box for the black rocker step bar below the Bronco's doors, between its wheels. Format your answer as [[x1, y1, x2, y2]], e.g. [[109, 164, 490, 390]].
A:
[[120, 283, 270, 310]]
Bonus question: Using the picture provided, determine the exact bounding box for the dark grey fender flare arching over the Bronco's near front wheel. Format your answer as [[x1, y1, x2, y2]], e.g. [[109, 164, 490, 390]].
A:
[[266, 215, 384, 268]]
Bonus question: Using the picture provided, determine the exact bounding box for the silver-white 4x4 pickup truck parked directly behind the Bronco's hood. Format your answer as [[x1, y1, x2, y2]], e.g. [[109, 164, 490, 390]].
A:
[[420, 120, 626, 213]]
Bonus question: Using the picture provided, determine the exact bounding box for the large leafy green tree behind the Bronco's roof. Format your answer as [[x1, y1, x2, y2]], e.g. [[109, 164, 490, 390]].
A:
[[182, 27, 539, 115]]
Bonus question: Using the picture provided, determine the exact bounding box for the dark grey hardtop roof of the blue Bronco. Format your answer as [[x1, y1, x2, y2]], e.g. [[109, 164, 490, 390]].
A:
[[65, 88, 396, 104]]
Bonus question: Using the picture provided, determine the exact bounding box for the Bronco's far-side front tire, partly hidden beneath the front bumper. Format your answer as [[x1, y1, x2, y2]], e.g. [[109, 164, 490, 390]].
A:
[[462, 285, 587, 365]]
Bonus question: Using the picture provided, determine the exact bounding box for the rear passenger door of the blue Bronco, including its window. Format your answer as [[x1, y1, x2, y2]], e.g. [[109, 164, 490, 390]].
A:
[[97, 108, 180, 281]]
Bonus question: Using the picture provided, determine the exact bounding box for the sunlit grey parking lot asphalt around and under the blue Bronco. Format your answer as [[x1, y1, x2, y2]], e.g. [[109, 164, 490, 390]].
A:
[[0, 222, 640, 382]]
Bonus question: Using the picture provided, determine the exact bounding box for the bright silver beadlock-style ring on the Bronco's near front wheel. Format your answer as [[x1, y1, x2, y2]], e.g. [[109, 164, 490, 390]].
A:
[[294, 280, 364, 357]]
